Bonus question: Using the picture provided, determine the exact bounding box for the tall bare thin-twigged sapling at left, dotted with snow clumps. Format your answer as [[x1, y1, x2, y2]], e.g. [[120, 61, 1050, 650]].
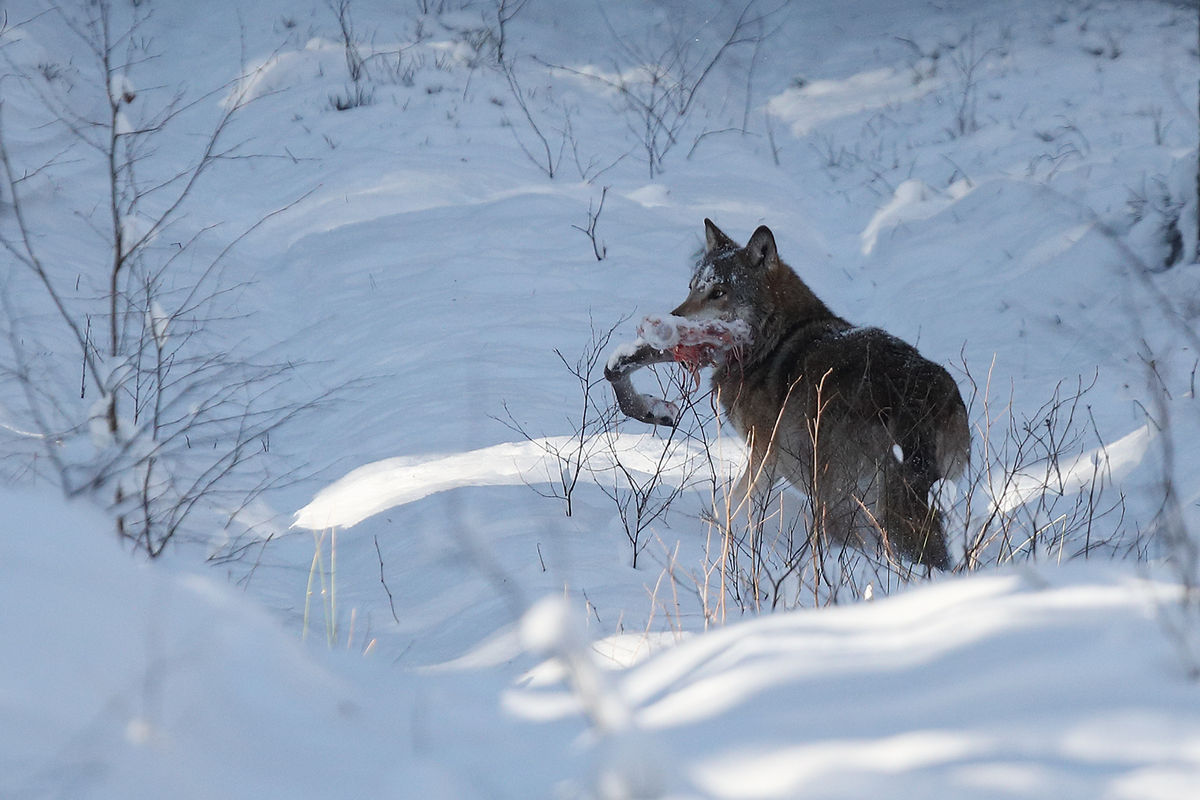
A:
[[0, 0, 324, 557]]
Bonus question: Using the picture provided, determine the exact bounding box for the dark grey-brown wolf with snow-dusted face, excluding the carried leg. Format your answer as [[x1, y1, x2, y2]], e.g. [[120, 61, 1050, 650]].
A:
[[673, 219, 971, 569]]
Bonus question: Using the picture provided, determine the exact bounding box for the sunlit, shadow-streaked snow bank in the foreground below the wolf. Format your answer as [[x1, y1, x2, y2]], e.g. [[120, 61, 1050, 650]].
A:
[[506, 569, 1200, 800]]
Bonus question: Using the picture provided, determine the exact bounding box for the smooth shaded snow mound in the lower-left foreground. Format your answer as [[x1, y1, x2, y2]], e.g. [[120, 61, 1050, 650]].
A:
[[0, 489, 410, 800]]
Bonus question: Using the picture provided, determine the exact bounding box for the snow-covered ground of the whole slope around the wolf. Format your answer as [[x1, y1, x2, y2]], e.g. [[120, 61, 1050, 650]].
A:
[[0, 0, 1200, 800]]
